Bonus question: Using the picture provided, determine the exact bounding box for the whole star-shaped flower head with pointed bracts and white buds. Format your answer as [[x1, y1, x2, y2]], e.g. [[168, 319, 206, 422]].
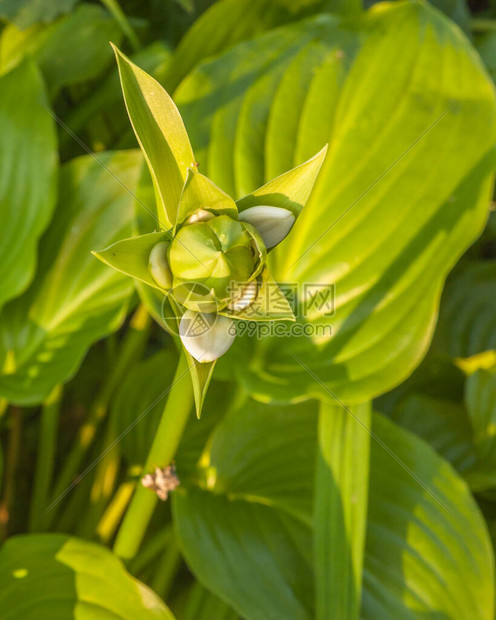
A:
[[95, 49, 327, 414]]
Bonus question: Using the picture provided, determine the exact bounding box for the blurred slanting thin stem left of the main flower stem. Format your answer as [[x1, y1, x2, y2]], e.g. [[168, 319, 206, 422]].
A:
[[47, 306, 150, 523]]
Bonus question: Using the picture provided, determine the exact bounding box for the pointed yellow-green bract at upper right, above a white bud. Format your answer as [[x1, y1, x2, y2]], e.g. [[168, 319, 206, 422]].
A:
[[236, 145, 327, 217]]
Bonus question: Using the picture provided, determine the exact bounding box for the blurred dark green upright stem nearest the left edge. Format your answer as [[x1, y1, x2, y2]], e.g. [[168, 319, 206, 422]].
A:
[[29, 385, 62, 531]]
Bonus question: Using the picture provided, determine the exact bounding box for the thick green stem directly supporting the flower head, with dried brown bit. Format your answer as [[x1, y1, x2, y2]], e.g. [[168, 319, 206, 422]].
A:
[[114, 355, 193, 559]]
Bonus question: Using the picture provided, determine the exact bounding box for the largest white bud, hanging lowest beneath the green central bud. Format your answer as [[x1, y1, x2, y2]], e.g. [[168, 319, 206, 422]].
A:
[[179, 310, 236, 363]]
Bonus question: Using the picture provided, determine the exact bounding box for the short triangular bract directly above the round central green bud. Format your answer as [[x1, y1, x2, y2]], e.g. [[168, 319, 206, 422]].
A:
[[176, 168, 238, 224]]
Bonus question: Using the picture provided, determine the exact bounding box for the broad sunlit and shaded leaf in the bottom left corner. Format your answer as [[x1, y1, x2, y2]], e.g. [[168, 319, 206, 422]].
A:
[[0, 534, 174, 620]]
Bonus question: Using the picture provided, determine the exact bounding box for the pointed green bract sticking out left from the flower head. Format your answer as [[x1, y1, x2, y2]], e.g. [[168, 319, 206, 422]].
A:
[[93, 232, 172, 291]]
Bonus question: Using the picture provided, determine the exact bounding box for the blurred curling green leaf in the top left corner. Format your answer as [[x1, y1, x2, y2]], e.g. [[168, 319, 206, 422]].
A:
[[0, 3, 122, 98]]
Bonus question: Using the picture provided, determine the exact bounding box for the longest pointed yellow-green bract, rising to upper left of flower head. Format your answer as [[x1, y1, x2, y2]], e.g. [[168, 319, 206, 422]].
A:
[[114, 47, 195, 228]]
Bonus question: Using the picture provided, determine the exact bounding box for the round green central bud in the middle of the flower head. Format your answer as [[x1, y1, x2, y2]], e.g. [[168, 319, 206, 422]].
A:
[[169, 215, 265, 312]]
